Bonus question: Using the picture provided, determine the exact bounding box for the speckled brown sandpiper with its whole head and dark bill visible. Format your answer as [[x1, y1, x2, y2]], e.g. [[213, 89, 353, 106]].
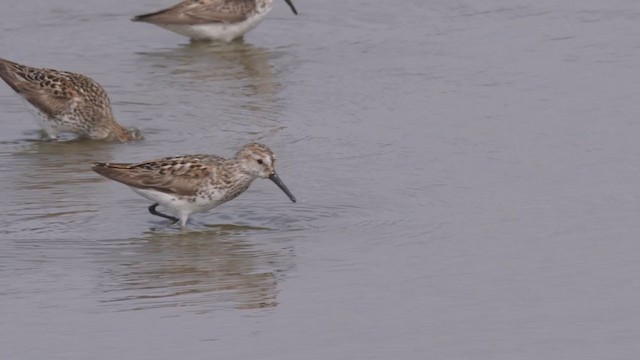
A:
[[92, 143, 296, 228]]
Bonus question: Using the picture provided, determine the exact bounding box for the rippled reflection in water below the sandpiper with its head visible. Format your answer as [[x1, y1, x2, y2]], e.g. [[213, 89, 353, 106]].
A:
[[99, 229, 293, 313]]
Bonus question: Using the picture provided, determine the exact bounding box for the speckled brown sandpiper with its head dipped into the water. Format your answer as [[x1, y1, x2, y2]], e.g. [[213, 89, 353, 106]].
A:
[[0, 59, 142, 142]]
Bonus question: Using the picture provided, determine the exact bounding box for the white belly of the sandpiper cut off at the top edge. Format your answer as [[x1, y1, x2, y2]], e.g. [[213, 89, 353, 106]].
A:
[[158, 9, 270, 42]]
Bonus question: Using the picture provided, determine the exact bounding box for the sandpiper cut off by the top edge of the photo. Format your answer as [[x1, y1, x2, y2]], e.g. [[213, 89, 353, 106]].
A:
[[131, 0, 298, 42]]
